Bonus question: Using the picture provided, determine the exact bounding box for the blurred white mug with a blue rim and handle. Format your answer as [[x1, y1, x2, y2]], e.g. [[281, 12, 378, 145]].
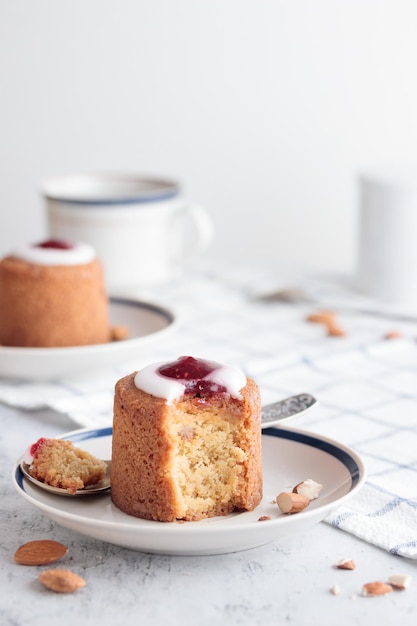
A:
[[41, 172, 213, 295]]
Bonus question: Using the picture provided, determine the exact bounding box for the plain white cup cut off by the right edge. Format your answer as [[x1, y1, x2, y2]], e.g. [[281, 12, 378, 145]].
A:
[[356, 164, 417, 312]]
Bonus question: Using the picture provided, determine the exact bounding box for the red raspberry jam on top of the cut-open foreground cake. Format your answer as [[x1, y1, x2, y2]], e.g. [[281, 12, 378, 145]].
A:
[[158, 356, 227, 397]]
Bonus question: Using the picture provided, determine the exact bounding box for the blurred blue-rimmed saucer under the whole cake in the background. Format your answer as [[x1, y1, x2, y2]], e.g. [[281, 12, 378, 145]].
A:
[[0, 298, 175, 381]]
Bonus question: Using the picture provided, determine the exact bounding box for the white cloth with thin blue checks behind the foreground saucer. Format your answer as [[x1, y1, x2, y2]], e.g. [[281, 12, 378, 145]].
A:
[[0, 267, 417, 559]]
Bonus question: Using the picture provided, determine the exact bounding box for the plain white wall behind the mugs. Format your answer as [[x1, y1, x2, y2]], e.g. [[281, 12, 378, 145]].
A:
[[0, 0, 417, 272]]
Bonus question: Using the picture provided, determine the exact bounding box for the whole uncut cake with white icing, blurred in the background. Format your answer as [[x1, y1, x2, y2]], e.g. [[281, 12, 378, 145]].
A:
[[0, 239, 111, 348]]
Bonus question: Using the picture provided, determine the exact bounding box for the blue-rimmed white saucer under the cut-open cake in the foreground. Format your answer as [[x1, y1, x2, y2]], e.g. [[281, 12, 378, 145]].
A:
[[13, 428, 366, 555]]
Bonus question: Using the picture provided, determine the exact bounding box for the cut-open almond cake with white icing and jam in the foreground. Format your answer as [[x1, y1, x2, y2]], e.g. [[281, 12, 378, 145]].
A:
[[111, 356, 262, 522]]
